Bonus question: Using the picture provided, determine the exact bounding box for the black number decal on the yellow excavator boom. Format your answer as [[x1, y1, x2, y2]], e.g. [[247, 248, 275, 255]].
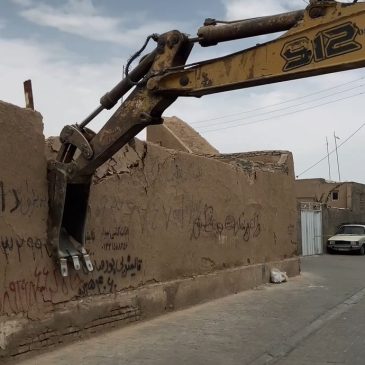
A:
[[281, 22, 362, 72]]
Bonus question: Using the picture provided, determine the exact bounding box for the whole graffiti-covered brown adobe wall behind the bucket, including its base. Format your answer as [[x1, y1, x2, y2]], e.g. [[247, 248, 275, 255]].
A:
[[0, 102, 299, 358]]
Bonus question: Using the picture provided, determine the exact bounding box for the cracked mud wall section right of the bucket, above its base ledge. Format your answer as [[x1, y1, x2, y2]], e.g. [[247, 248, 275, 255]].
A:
[[84, 142, 296, 282]]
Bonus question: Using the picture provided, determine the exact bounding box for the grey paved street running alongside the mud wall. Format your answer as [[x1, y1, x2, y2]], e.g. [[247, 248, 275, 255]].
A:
[[15, 255, 365, 365]]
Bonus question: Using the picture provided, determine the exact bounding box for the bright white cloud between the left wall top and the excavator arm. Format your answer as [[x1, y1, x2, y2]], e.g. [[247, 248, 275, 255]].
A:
[[0, 38, 125, 136]]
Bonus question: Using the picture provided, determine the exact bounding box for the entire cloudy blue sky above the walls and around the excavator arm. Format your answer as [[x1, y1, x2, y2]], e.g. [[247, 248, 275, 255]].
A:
[[0, 0, 365, 183]]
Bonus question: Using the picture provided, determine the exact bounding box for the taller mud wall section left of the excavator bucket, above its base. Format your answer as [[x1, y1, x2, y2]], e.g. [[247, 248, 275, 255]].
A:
[[0, 103, 48, 318]]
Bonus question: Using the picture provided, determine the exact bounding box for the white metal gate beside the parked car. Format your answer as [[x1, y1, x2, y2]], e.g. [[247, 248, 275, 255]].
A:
[[300, 202, 323, 256]]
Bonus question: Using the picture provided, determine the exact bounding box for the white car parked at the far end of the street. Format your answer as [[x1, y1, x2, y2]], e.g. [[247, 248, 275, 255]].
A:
[[327, 224, 365, 255]]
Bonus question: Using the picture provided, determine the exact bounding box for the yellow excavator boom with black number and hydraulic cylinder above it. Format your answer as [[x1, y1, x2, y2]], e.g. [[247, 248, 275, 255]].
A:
[[152, 1, 365, 97]]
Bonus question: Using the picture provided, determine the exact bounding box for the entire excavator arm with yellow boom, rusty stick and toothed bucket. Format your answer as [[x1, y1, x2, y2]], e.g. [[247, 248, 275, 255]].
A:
[[48, 0, 365, 276]]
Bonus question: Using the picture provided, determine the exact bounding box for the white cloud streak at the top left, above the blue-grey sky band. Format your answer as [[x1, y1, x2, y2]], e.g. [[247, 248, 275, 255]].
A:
[[13, 0, 183, 47]]
